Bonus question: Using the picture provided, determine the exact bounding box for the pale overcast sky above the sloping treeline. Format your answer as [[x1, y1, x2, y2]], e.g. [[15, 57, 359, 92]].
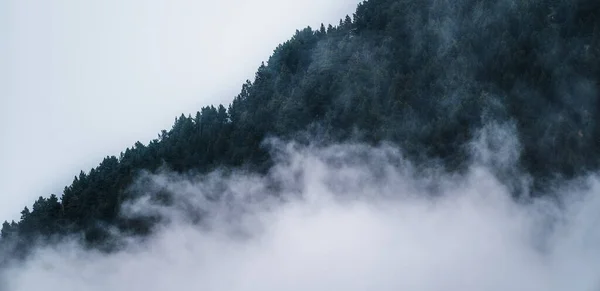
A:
[[0, 0, 359, 220]]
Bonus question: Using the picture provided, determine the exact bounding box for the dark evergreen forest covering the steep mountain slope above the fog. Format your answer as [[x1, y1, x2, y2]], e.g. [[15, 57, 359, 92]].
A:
[[0, 0, 600, 260]]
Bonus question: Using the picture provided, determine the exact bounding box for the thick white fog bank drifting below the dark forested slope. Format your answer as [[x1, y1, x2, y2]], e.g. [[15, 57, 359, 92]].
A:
[[0, 126, 600, 291]]
